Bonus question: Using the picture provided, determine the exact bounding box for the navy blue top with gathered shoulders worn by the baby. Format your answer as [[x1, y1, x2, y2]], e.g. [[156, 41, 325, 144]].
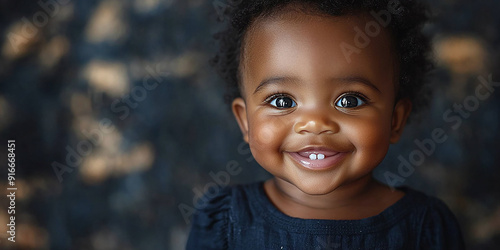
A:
[[186, 182, 464, 250]]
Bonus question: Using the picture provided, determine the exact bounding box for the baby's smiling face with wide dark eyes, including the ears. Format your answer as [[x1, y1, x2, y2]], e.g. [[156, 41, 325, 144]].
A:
[[233, 13, 411, 194]]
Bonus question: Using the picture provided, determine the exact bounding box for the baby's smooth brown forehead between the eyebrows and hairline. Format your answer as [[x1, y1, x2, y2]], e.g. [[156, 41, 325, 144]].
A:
[[240, 12, 397, 90]]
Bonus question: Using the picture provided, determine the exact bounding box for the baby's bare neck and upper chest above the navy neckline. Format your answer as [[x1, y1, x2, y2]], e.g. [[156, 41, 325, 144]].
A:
[[264, 176, 404, 220]]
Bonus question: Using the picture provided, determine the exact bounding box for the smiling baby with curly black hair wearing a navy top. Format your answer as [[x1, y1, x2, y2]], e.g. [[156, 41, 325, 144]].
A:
[[187, 0, 463, 249]]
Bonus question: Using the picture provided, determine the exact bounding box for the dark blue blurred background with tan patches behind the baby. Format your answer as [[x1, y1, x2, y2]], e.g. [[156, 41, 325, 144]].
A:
[[0, 0, 500, 249]]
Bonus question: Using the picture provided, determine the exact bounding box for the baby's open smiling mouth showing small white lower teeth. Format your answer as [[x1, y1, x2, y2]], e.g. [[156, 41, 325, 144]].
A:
[[287, 147, 347, 170]]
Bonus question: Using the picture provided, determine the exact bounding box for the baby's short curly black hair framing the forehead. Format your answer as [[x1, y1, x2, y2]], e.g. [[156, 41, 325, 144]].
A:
[[211, 0, 433, 116]]
